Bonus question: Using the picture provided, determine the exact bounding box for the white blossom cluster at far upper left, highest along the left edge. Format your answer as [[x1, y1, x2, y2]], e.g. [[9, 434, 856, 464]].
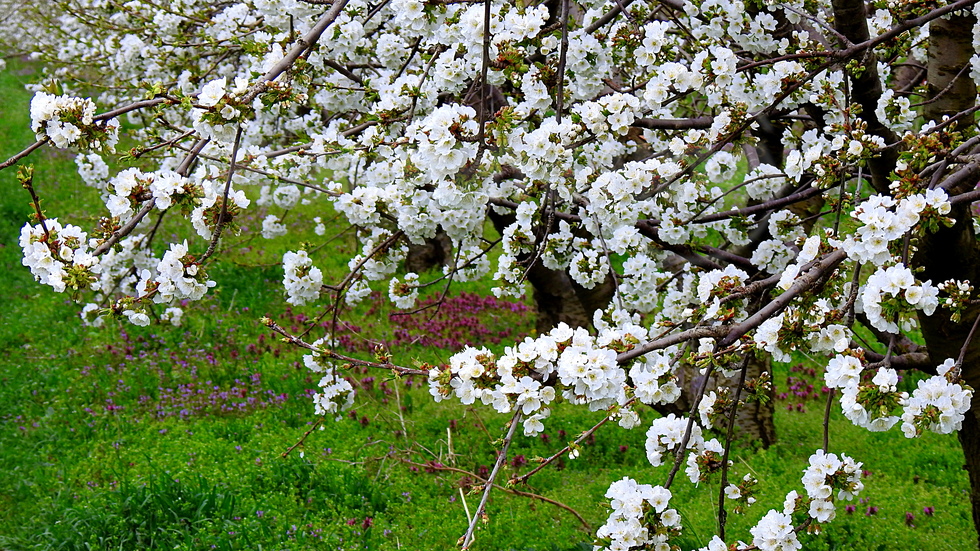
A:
[[31, 92, 119, 151]]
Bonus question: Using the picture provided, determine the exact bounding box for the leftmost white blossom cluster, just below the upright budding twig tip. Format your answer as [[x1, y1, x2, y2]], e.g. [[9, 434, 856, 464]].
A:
[[20, 218, 102, 293]]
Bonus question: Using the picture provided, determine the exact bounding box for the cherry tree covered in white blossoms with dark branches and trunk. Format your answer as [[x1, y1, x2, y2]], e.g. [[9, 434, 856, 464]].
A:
[[0, 0, 980, 551]]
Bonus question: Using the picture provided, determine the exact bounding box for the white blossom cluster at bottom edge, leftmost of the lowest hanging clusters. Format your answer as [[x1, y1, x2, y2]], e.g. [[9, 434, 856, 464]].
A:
[[593, 477, 681, 551]]
